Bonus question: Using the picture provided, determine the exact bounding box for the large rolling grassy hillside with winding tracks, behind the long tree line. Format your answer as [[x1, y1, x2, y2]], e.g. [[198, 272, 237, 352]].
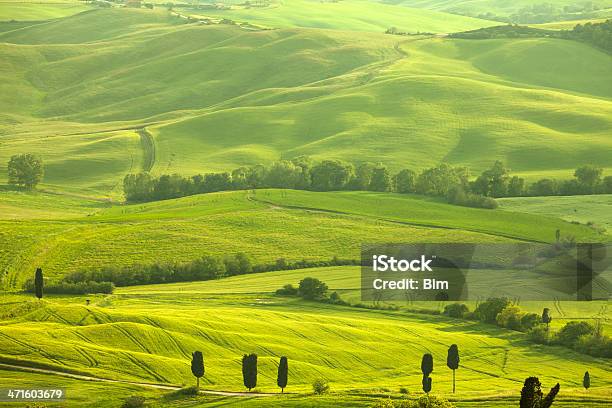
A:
[[0, 8, 612, 199]]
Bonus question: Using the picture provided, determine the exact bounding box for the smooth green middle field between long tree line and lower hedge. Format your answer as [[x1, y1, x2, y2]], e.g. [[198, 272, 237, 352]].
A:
[[0, 190, 606, 287]]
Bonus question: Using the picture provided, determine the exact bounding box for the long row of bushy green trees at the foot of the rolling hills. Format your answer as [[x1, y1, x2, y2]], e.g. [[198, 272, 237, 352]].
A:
[[123, 156, 612, 209]]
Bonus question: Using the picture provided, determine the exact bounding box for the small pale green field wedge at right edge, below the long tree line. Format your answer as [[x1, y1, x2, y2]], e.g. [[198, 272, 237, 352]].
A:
[[499, 195, 612, 231]]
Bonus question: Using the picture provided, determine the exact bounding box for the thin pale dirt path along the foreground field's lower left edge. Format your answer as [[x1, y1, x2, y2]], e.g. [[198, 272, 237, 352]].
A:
[[0, 363, 276, 397]]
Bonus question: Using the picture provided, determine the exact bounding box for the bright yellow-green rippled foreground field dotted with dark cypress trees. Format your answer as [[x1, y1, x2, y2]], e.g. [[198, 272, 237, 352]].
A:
[[0, 268, 612, 406]]
